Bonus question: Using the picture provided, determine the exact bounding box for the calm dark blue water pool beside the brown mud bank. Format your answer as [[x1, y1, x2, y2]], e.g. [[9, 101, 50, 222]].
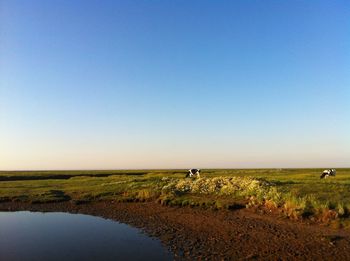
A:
[[0, 211, 172, 261]]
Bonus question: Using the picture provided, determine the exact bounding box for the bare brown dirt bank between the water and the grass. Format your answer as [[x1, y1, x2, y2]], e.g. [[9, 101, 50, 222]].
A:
[[0, 202, 350, 260]]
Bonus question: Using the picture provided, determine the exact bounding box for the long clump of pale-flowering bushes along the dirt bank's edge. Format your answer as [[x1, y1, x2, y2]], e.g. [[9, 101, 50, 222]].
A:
[[161, 177, 350, 223]]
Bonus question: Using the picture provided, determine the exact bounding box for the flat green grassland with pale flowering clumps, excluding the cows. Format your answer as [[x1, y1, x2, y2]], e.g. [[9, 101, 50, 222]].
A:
[[0, 168, 350, 224]]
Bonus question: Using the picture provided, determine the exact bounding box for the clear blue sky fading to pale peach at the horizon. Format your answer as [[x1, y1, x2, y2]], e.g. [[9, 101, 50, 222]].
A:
[[0, 0, 350, 170]]
